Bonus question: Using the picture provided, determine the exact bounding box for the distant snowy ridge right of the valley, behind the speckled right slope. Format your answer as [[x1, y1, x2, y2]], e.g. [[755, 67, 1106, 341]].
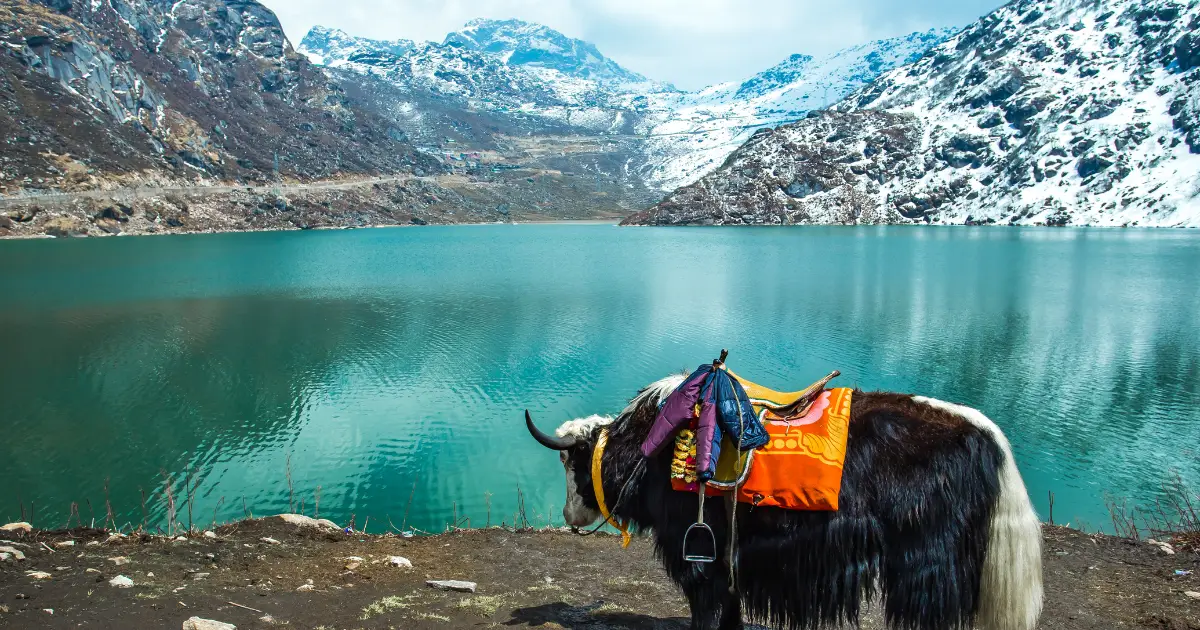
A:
[[646, 29, 955, 190]]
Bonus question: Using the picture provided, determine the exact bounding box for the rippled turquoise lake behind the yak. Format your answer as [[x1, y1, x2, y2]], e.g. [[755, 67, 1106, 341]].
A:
[[0, 224, 1200, 533]]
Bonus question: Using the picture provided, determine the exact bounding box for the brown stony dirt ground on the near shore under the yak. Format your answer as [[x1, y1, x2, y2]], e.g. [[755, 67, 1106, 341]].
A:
[[0, 518, 1200, 630]]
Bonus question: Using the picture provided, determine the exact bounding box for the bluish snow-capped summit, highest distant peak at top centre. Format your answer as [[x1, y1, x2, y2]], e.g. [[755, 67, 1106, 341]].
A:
[[443, 19, 647, 84]]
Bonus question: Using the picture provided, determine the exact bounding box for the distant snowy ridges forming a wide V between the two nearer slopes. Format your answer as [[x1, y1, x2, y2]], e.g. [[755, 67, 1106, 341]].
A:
[[300, 19, 953, 190]]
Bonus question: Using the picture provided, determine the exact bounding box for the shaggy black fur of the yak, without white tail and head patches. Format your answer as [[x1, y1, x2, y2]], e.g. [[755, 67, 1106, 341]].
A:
[[556, 391, 1006, 630]]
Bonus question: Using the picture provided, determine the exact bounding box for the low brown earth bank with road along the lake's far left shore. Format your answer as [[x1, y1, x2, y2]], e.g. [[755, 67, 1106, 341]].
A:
[[0, 170, 629, 238]]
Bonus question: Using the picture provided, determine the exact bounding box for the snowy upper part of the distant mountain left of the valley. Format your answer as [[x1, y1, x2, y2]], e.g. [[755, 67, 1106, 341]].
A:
[[300, 19, 673, 133]]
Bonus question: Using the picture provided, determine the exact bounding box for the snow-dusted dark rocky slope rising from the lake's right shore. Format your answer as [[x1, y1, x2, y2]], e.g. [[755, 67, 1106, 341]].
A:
[[626, 0, 1200, 227]]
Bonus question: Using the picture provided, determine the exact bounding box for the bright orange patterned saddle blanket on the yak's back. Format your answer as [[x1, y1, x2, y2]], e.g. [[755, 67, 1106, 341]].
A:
[[671, 373, 853, 511]]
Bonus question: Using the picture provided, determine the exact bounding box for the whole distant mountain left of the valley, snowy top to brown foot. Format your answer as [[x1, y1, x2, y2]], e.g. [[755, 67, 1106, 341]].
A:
[[299, 20, 673, 215]]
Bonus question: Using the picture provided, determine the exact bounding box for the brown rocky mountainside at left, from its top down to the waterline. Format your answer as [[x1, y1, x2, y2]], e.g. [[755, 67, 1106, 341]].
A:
[[0, 0, 653, 238]]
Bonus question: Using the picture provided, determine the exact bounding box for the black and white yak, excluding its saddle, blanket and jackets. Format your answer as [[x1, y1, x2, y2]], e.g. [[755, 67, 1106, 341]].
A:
[[526, 376, 1042, 630]]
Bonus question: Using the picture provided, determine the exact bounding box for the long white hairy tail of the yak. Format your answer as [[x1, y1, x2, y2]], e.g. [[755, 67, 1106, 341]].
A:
[[914, 397, 1042, 630]]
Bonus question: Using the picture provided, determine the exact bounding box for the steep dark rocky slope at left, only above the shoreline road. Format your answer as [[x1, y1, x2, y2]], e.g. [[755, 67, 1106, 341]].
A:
[[0, 0, 436, 193]]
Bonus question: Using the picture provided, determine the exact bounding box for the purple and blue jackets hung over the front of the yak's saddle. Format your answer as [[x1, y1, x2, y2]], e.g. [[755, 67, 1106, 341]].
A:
[[642, 364, 770, 481]]
